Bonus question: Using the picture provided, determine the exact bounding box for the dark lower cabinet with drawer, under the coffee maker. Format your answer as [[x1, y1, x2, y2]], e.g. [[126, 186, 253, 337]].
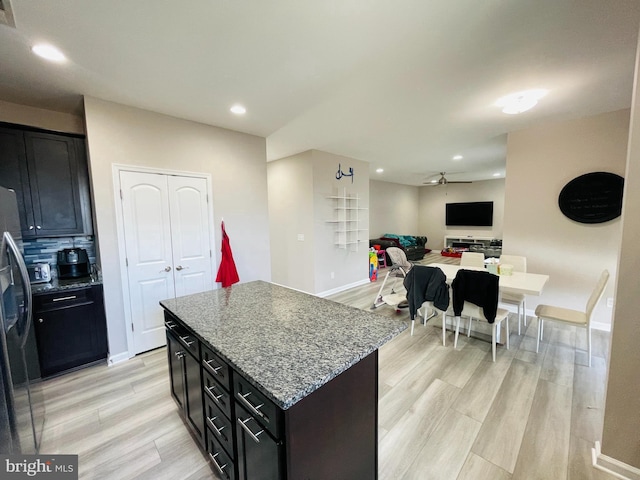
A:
[[33, 285, 107, 377]]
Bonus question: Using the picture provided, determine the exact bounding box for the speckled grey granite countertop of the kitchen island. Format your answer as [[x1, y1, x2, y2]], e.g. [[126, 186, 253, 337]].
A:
[[160, 281, 407, 409]]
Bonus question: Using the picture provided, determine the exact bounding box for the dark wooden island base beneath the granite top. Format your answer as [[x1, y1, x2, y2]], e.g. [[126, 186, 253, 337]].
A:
[[165, 312, 378, 480]]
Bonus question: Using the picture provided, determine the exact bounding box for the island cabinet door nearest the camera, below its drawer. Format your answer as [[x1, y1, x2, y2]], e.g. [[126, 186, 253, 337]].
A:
[[236, 404, 284, 480]]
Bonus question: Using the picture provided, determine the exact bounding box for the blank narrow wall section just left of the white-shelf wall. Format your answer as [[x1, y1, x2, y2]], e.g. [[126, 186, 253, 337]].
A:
[[267, 152, 315, 292]]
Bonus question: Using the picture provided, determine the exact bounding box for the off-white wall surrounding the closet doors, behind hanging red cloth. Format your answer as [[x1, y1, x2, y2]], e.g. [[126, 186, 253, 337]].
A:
[[85, 98, 271, 357]]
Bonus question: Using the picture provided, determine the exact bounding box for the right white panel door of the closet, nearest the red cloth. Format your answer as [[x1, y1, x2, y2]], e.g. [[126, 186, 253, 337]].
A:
[[168, 176, 213, 297]]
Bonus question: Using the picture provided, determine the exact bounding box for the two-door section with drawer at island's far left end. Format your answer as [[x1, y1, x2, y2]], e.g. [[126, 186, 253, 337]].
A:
[[165, 322, 205, 448]]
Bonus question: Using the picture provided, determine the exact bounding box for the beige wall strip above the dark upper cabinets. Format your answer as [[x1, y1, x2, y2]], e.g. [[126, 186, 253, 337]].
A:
[[0, 100, 84, 134]]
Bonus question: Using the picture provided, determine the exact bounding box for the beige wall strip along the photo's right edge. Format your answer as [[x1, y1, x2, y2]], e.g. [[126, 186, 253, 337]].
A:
[[602, 31, 640, 466]]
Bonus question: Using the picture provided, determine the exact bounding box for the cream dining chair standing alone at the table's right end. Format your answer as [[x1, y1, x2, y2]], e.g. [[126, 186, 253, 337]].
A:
[[536, 269, 609, 366]]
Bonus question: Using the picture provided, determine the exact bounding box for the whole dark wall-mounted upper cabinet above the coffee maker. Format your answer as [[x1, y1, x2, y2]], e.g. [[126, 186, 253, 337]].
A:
[[0, 124, 93, 238]]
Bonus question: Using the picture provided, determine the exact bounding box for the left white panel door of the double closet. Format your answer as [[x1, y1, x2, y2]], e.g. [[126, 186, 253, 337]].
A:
[[120, 171, 175, 353]]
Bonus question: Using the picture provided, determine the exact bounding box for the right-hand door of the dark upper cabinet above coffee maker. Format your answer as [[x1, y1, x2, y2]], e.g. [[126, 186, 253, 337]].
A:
[[24, 132, 84, 236]]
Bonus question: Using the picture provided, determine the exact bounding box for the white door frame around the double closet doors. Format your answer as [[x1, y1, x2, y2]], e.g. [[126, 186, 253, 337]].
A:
[[111, 163, 218, 358]]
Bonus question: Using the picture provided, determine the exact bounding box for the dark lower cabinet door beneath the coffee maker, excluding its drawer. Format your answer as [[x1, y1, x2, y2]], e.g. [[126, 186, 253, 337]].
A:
[[34, 303, 106, 376]]
